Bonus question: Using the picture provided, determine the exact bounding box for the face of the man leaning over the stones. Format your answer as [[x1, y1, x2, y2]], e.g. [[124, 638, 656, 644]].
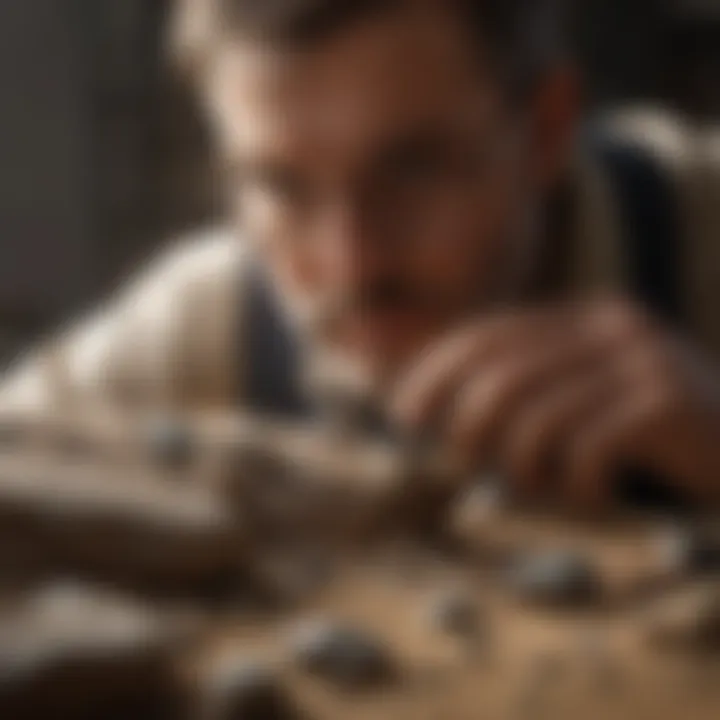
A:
[[211, 3, 572, 380]]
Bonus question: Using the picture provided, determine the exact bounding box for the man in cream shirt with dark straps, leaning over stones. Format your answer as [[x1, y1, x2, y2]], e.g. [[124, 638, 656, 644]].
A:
[[3, 0, 720, 506]]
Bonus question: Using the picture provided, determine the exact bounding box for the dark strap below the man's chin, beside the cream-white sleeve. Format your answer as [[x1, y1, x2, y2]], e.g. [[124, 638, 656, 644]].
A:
[[238, 262, 309, 415]]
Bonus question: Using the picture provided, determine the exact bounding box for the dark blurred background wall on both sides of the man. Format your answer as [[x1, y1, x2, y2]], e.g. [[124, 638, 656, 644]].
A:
[[0, 0, 720, 364]]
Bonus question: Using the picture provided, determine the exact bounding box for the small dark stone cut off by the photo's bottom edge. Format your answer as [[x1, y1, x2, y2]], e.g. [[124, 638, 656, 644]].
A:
[[202, 657, 295, 720]]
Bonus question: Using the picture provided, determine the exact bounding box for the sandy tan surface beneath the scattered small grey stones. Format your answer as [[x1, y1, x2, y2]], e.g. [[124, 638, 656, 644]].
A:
[[188, 524, 720, 720]]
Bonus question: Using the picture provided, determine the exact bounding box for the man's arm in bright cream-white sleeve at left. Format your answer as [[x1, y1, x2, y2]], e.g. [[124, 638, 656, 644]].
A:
[[0, 225, 241, 413]]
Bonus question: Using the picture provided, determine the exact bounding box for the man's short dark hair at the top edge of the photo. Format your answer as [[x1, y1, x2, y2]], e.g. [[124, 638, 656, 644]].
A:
[[174, 0, 565, 100]]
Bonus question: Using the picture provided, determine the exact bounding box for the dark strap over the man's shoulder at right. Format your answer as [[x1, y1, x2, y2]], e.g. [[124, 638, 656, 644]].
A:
[[593, 134, 683, 324]]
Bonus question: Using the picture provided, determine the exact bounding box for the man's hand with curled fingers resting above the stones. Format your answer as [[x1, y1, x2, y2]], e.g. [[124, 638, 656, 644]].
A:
[[393, 300, 720, 506]]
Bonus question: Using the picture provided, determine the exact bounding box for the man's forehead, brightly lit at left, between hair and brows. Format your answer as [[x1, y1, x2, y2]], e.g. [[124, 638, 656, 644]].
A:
[[205, 5, 500, 162]]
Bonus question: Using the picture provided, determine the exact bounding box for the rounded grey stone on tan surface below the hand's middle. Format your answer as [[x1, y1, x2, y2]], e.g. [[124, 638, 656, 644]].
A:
[[509, 551, 601, 606]]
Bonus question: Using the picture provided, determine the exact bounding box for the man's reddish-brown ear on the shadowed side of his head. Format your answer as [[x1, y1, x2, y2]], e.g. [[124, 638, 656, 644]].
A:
[[531, 64, 582, 187]]
